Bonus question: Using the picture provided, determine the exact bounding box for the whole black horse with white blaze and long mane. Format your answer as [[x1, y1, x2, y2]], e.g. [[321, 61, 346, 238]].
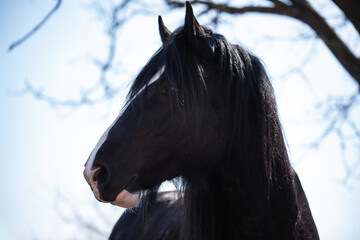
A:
[[84, 2, 319, 240]]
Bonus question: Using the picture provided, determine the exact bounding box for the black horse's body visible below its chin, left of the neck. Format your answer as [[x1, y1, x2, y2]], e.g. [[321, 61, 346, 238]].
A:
[[109, 192, 184, 240]]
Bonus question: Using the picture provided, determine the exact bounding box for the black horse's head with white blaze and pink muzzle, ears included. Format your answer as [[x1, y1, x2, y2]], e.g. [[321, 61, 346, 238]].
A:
[[84, 2, 231, 207]]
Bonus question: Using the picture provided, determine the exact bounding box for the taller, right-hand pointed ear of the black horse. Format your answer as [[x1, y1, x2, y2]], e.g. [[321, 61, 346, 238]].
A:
[[184, 1, 215, 59]]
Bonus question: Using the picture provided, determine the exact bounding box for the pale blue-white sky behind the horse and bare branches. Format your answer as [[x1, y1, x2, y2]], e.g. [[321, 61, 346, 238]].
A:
[[0, 0, 360, 240]]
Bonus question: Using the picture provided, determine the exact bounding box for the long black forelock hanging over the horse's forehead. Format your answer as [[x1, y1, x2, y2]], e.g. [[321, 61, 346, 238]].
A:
[[127, 28, 206, 112]]
